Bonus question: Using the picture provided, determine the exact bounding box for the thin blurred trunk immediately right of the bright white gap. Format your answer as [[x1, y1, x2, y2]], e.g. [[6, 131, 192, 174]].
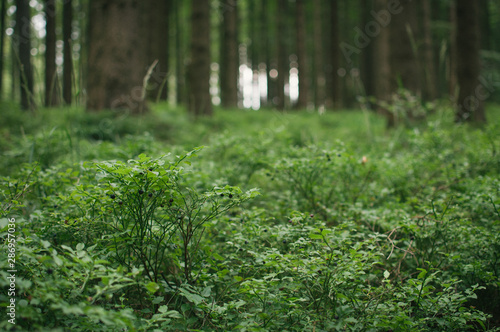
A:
[[295, 0, 309, 109]]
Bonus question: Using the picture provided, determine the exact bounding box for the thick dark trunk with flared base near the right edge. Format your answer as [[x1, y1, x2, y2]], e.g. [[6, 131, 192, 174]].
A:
[[455, 0, 489, 123]]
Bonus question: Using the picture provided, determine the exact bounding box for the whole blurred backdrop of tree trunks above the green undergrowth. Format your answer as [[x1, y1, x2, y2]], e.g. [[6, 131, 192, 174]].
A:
[[0, 0, 500, 125]]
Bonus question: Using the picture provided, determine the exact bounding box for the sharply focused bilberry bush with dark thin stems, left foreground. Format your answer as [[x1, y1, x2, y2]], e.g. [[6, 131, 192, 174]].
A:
[[65, 149, 258, 286]]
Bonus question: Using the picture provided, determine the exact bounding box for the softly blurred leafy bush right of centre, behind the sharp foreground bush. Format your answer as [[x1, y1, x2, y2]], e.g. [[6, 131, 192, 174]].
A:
[[270, 146, 374, 221]]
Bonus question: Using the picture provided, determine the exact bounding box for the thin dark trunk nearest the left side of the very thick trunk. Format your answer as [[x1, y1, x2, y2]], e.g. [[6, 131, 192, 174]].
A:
[[63, 0, 72, 105]]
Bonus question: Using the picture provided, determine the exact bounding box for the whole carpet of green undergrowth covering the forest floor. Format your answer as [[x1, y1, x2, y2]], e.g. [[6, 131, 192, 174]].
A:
[[0, 105, 500, 331]]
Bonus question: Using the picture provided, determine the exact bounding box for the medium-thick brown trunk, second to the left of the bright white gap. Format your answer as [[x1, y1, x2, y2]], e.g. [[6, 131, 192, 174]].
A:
[[188, 0, 212, 117]]
